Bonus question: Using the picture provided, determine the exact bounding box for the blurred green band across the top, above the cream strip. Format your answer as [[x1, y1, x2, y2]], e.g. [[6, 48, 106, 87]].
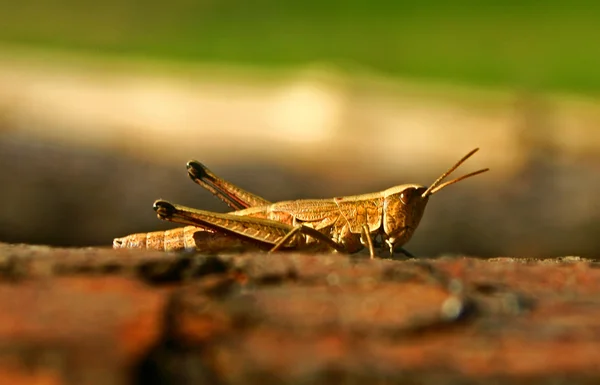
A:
[[0, 0, 600, 93]]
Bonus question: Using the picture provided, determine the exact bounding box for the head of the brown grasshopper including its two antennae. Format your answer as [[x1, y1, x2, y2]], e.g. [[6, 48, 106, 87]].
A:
[[383, 148, 489, 251]]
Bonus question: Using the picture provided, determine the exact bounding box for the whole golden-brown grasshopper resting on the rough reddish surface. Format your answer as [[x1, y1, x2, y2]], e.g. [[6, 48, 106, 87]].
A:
[[113, 149, 488, 258]]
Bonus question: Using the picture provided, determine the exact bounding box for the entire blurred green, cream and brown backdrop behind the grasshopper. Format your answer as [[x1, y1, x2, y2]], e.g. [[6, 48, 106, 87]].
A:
[[0, 0, 600, 257]]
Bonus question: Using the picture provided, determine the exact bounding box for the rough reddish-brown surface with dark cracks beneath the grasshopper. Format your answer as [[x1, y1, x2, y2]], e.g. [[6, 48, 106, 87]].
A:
[[0, 244, 600, 384]]
